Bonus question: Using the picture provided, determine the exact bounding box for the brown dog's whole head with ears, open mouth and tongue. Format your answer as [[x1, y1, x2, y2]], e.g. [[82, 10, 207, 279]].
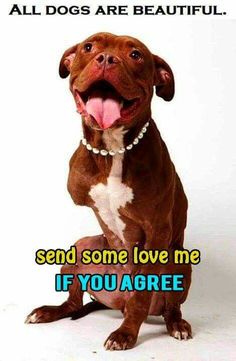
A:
[[59, 33, 174, 129]]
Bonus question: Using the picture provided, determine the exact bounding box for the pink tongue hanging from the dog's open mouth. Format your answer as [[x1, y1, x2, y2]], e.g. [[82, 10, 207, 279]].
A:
[[86, 96, 120, 129]]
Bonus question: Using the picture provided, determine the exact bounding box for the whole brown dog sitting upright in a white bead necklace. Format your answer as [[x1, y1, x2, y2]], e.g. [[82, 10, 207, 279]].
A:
[[27, 33, 191, 350]]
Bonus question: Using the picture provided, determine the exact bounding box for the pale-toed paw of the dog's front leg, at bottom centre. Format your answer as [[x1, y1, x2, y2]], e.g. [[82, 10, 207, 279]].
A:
[[104, 328, 137, 351]]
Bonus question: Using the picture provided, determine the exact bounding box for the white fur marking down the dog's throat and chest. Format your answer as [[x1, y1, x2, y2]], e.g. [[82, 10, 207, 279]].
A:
[[89, 127, 133, 241]]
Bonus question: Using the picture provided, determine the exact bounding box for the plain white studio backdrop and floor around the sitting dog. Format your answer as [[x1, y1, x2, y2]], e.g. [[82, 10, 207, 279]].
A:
[[0, 2, 236, 361]]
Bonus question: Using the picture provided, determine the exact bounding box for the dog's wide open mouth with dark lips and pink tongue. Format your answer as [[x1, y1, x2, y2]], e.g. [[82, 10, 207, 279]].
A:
[[74, 80, 140, 129]]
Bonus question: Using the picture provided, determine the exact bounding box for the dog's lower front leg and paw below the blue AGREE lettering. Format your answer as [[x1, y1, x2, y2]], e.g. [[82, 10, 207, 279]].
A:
[[104, 291, 152, 350]]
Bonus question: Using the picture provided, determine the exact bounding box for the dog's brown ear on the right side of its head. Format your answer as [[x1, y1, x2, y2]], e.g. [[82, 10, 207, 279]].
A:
[[153, 55, 175, 101]]
